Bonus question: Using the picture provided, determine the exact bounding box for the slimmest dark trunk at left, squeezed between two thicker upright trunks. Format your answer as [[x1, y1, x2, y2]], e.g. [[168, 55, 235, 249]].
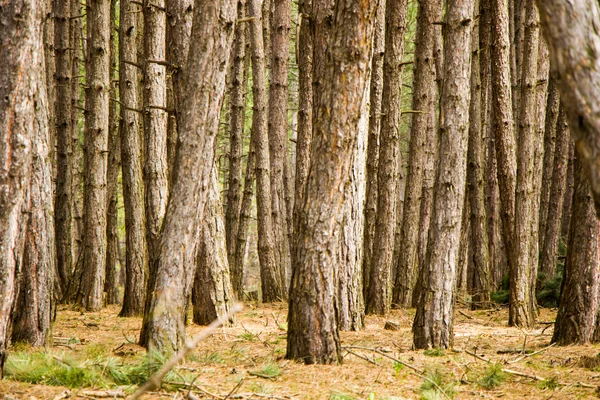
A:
[[104, 0, 121, 304]]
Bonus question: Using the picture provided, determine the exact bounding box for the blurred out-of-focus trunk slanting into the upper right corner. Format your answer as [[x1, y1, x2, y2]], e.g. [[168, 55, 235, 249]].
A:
[[537, 0, 600, 215]]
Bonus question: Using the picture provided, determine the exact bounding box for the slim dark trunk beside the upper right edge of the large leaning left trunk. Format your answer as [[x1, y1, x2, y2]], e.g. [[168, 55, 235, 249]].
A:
[[225, 1, 246, 292]]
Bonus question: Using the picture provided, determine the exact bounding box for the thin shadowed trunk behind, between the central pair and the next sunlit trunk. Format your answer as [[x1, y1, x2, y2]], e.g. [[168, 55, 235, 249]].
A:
[[360, 0, 386, 297]]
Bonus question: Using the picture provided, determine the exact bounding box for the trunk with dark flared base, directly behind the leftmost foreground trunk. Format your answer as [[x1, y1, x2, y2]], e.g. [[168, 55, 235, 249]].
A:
[[12, 54, 56, 346]]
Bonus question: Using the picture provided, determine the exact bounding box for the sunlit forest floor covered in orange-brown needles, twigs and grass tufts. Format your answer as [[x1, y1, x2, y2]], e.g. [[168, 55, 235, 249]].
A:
[[0, 304, 600, 400]]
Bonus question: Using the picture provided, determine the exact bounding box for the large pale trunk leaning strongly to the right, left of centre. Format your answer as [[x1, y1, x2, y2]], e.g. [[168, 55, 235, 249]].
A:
[[140, 0, 236, 351]]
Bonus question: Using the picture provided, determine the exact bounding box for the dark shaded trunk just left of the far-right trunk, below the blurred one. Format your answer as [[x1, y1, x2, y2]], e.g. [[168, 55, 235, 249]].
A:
[[541, 109, 571, 279]]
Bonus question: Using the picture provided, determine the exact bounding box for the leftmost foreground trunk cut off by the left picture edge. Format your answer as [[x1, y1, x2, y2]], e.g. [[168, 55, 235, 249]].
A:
[[0, 0, 40, 378]]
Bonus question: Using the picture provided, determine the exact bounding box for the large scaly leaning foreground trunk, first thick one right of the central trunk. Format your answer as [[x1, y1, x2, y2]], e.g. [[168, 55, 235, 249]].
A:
[[413, 0, 473, 348]]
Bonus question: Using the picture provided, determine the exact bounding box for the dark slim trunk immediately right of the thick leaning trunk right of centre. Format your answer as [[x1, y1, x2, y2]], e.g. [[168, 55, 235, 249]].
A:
[[467, 10, 491, 308]]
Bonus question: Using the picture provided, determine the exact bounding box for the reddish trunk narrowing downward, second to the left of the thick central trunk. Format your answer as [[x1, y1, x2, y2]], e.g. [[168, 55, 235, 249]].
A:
[[264, 0, 291, 290]]
